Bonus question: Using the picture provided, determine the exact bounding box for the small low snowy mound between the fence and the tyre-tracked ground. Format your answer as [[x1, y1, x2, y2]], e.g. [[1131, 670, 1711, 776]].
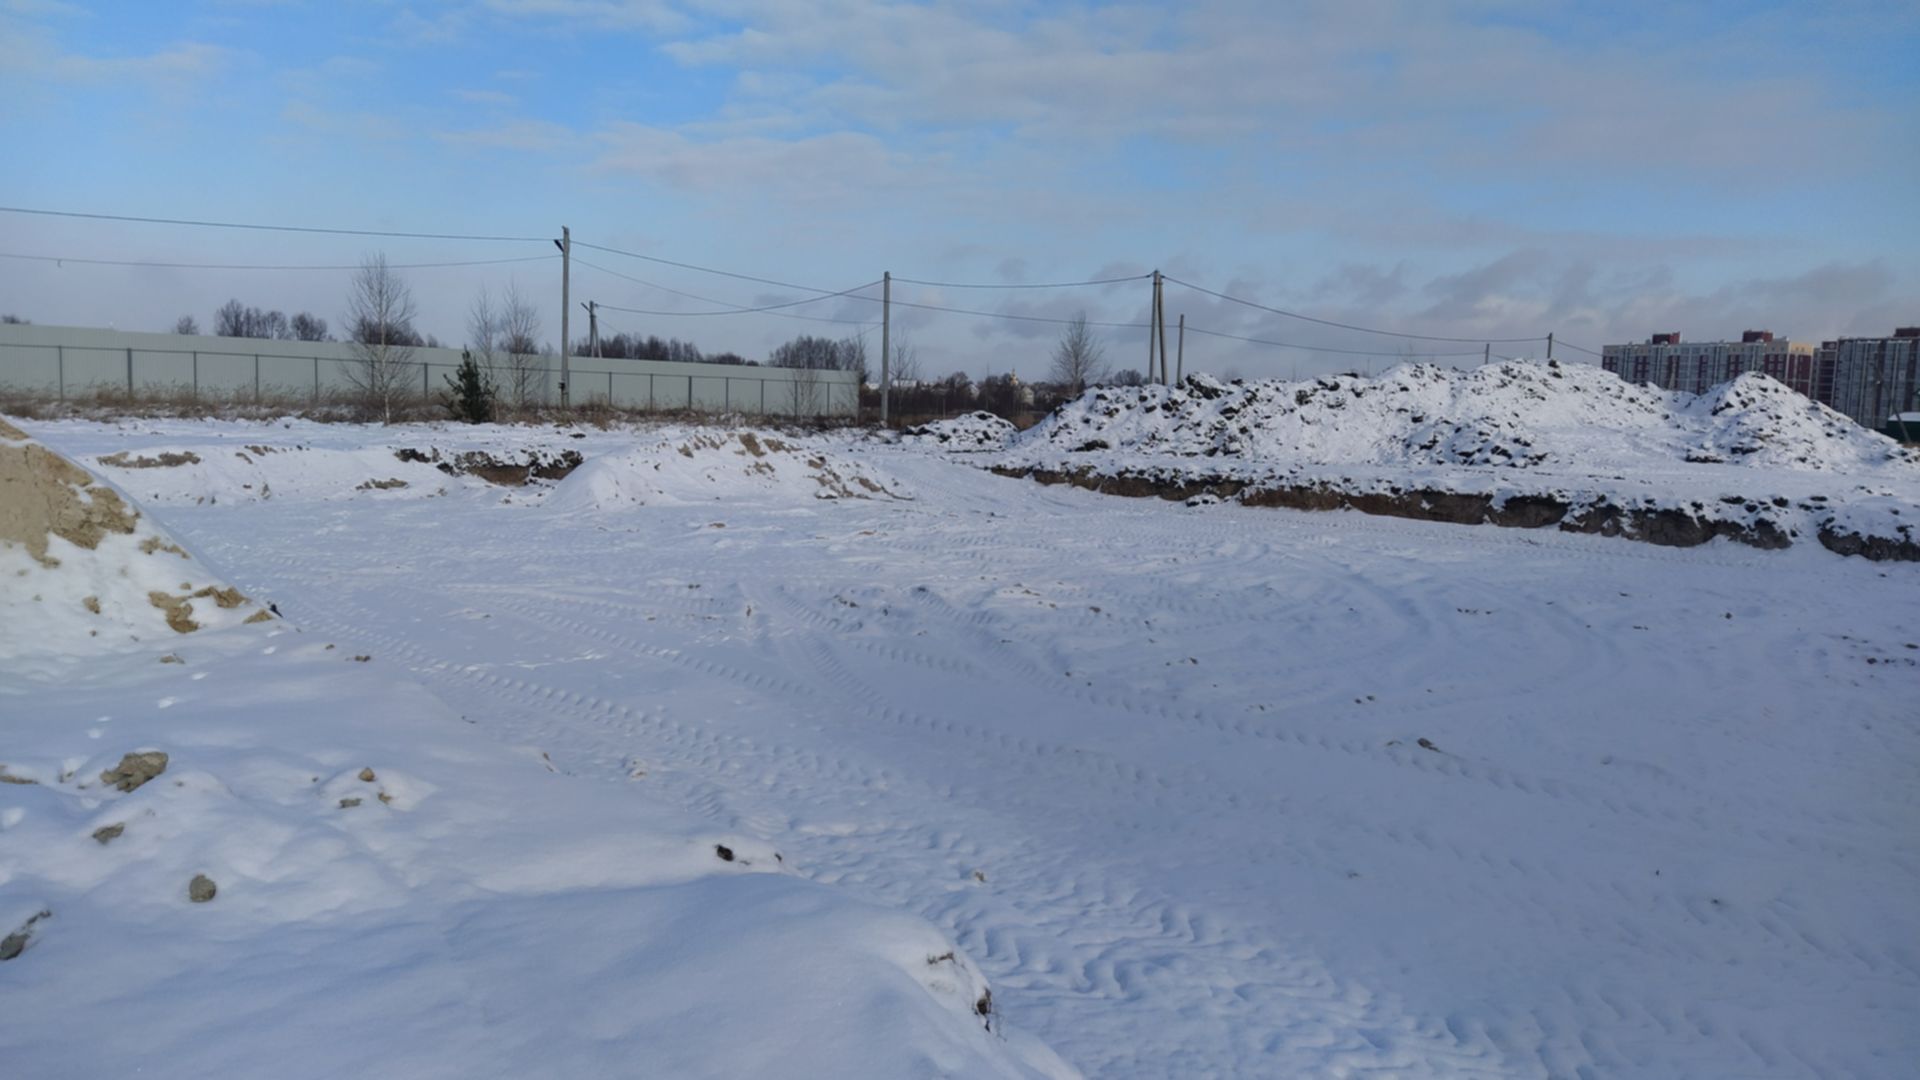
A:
[[545, 429, 912, 511]]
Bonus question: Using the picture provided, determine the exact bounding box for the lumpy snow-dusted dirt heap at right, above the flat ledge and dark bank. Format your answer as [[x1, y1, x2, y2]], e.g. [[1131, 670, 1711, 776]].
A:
[[1016, 363, 1920, 469]]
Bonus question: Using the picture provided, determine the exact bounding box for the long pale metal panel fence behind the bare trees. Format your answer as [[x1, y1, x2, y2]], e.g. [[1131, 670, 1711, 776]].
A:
[[0, 325, 860, 417]]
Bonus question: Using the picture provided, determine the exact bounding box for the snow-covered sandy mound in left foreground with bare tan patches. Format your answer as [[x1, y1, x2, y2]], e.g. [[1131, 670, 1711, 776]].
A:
[[0, 413, 1071, 1078]]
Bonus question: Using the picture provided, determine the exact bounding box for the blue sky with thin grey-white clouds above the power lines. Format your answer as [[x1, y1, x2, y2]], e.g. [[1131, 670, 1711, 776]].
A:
[[0, 0, 1920, 377]]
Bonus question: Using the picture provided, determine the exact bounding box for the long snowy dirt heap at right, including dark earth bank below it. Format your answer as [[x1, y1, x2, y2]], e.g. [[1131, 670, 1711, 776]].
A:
[[983, 363, 1920, 559]]
